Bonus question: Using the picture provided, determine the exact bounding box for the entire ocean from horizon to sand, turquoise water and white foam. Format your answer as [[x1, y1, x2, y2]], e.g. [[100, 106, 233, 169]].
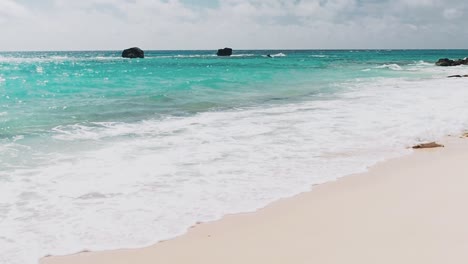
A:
[[0, 50, 468, 264]]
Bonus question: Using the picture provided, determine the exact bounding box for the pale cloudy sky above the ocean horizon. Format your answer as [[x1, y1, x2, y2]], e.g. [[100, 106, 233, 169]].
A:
[[0, 0, 468, 51]]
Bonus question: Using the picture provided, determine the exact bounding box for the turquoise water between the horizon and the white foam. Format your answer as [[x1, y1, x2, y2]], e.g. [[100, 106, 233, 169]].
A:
[[0, 50, 467, 138]]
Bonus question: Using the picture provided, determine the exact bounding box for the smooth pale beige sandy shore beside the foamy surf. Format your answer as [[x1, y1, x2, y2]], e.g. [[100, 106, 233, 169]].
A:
[[41, 137, 468, 264]]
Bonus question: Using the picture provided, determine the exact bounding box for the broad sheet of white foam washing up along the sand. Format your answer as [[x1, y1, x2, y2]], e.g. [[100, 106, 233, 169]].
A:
[[0, 73, 468, 264]]
